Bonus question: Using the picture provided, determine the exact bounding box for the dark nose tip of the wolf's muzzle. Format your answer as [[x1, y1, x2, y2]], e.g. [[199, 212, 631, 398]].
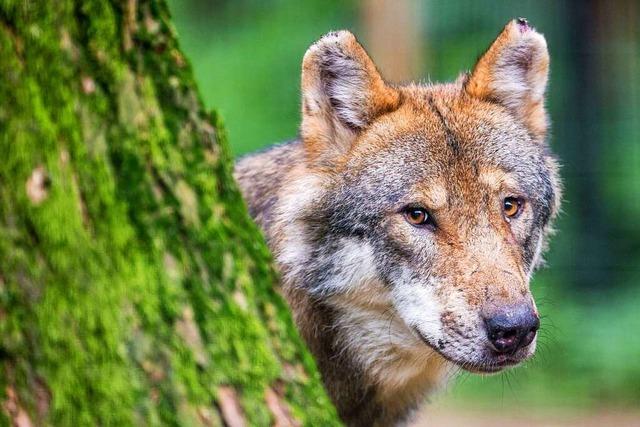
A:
[[485, 305, 540, 353]]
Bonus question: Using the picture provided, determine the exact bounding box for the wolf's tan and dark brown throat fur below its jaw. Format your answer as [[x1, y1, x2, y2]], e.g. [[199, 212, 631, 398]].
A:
[[285, 285, 452, 426]]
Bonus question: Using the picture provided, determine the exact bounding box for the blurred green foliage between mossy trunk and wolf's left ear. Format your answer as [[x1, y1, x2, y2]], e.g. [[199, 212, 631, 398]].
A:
[[171, 0, 356, 154]]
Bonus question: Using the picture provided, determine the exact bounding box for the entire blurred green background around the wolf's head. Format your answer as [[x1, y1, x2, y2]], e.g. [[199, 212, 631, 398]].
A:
[[170, 0, 640, 425]]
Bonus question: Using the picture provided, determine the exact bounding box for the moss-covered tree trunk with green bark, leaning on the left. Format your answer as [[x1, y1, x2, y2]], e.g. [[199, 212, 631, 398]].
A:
[[0, 0, 337, 426]]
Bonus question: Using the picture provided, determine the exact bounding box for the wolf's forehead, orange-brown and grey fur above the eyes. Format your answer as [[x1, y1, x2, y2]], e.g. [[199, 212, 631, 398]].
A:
[[322, 85, 556, 222]]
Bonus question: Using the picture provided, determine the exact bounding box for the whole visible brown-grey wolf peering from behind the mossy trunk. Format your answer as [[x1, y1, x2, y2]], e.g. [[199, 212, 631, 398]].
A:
[[234, 19, 561, 426]]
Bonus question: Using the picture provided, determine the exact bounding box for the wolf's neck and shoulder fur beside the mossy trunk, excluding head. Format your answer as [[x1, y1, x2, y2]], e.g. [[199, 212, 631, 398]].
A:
[[235, 141, 451, 426]]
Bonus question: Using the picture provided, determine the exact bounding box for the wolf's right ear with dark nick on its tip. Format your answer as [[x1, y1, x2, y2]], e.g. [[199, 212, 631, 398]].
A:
[[464, 18, 549, 139]]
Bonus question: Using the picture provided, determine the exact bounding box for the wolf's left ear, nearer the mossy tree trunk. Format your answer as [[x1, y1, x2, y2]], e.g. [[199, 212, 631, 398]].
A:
[[301, 31, 400, 164]]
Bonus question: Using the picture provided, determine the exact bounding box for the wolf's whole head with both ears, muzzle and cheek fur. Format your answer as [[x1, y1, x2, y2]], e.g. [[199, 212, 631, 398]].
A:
[[278, 20, 560, 378]]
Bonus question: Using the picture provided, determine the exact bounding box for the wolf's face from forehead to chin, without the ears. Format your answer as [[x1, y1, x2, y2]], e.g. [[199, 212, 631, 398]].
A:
[[307, 94, 557, 372]]
